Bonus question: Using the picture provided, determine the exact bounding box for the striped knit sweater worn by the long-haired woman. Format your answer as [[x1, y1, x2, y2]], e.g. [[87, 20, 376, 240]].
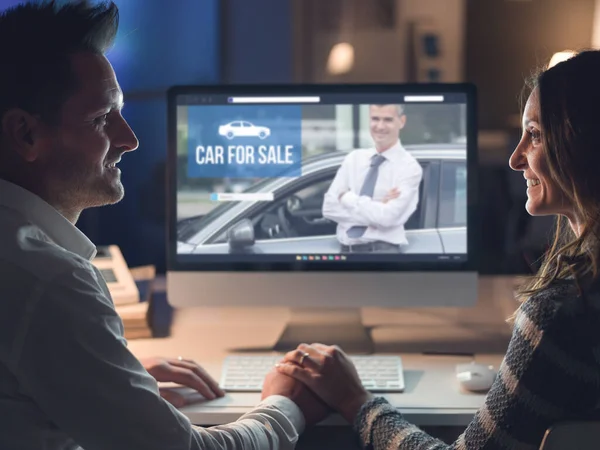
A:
[[354, 281, 600, 450]]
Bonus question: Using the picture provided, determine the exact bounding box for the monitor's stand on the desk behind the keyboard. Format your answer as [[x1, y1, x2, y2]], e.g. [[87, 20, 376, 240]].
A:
[[273, 308, 375, 354]]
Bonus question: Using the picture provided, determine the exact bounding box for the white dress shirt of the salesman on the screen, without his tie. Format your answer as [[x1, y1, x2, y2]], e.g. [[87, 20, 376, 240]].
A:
[[323, 141, 423, 245]]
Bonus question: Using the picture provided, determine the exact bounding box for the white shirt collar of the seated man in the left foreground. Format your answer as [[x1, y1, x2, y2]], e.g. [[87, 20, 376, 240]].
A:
[[0, 179, 96, 260]]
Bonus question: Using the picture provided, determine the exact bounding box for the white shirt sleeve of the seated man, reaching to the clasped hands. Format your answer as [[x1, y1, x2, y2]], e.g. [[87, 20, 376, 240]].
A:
[[15, 267, 304, 450]]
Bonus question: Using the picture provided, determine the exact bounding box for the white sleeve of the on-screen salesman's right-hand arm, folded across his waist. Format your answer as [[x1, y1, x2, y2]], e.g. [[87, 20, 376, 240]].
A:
[[341, 163, 423, 228]]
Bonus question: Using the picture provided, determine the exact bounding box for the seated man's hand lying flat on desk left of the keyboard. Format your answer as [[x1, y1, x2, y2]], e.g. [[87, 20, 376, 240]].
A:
[[140, 357, 225, 408]]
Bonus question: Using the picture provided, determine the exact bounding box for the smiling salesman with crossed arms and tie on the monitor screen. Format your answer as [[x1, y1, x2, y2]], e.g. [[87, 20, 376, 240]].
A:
[[323, 105, 423, 253]]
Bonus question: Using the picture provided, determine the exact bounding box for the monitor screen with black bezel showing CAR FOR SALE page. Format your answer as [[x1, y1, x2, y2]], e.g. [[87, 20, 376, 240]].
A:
[[168, 85, 476, 270]]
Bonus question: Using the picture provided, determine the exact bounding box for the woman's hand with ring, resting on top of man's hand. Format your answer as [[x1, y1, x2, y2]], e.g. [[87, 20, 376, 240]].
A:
[[276, 344, 372, 423]]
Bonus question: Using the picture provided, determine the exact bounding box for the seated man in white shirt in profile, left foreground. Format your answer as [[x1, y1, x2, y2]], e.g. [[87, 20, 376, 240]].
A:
[[0, 1, 326, 450]]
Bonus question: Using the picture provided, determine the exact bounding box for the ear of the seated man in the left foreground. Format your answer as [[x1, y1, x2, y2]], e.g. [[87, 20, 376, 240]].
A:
[[2, 108, 41, 162]]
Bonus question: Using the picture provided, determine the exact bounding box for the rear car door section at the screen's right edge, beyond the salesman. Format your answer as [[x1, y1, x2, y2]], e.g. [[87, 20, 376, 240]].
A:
[[438, 160, 467, 254]]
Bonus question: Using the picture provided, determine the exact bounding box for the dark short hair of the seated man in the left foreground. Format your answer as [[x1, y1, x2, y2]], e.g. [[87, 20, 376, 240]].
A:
[[0, 0, 119, 124]]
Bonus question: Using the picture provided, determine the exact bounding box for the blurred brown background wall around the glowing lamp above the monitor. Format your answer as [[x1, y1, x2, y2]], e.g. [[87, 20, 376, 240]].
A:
[[302, 0, 466, 82]]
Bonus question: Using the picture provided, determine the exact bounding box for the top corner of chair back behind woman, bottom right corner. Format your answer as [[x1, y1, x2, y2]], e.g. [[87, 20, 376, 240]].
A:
[[540, 421, 600, 450]]
